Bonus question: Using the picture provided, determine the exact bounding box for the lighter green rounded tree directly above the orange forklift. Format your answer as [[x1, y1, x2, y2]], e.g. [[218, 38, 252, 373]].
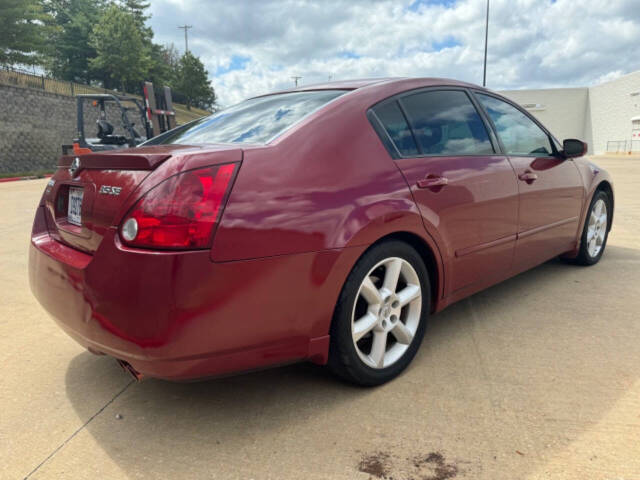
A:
[[89, 5, 150, 91]]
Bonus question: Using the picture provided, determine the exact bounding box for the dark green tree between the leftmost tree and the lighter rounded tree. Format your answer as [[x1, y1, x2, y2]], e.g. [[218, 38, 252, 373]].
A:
[[45, 0, 107, 83]]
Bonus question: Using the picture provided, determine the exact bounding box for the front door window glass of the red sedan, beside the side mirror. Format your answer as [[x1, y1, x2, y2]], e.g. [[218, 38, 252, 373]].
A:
[[476, 93, 553, 156]]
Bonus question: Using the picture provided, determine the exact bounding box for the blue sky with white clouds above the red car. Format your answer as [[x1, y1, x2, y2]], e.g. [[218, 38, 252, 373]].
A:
[[148, 0, 640, 106]]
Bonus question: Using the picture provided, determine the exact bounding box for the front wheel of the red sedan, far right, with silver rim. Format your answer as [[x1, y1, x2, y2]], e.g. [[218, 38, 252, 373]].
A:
[[572, 190, 611, 265]]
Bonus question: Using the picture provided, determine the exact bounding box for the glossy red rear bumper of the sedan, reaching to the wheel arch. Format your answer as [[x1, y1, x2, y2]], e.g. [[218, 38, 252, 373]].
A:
[[29, 209, 360, 379]]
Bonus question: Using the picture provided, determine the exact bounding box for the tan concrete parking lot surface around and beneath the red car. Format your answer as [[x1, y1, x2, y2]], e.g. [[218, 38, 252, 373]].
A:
[[0, 157, 640, 480]]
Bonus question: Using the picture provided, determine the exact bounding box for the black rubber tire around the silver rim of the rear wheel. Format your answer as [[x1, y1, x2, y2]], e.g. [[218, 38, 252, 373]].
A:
[[329, 240, 431, 386]]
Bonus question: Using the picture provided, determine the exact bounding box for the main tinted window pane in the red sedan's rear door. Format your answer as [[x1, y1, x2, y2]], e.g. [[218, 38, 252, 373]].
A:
[[400, 90, 494, 155]]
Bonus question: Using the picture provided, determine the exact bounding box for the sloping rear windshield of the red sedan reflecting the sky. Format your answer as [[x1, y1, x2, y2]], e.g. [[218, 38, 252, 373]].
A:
[[145, 90, 347, 145]]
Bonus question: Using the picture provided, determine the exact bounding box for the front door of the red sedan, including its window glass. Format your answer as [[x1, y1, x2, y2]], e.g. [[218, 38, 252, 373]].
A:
[[475, 92, 584, 273]]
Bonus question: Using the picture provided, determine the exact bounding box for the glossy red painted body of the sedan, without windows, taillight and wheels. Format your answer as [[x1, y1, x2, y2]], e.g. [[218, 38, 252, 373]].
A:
[[29, 79, 611, 379]]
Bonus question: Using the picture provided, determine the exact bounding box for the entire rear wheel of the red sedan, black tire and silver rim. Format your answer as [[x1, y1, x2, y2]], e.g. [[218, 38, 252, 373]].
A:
[[329, 240, 431, 386]]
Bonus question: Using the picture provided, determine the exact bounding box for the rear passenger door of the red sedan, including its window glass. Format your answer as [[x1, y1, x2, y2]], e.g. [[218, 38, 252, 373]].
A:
[[373, 88, 518, 296]]
